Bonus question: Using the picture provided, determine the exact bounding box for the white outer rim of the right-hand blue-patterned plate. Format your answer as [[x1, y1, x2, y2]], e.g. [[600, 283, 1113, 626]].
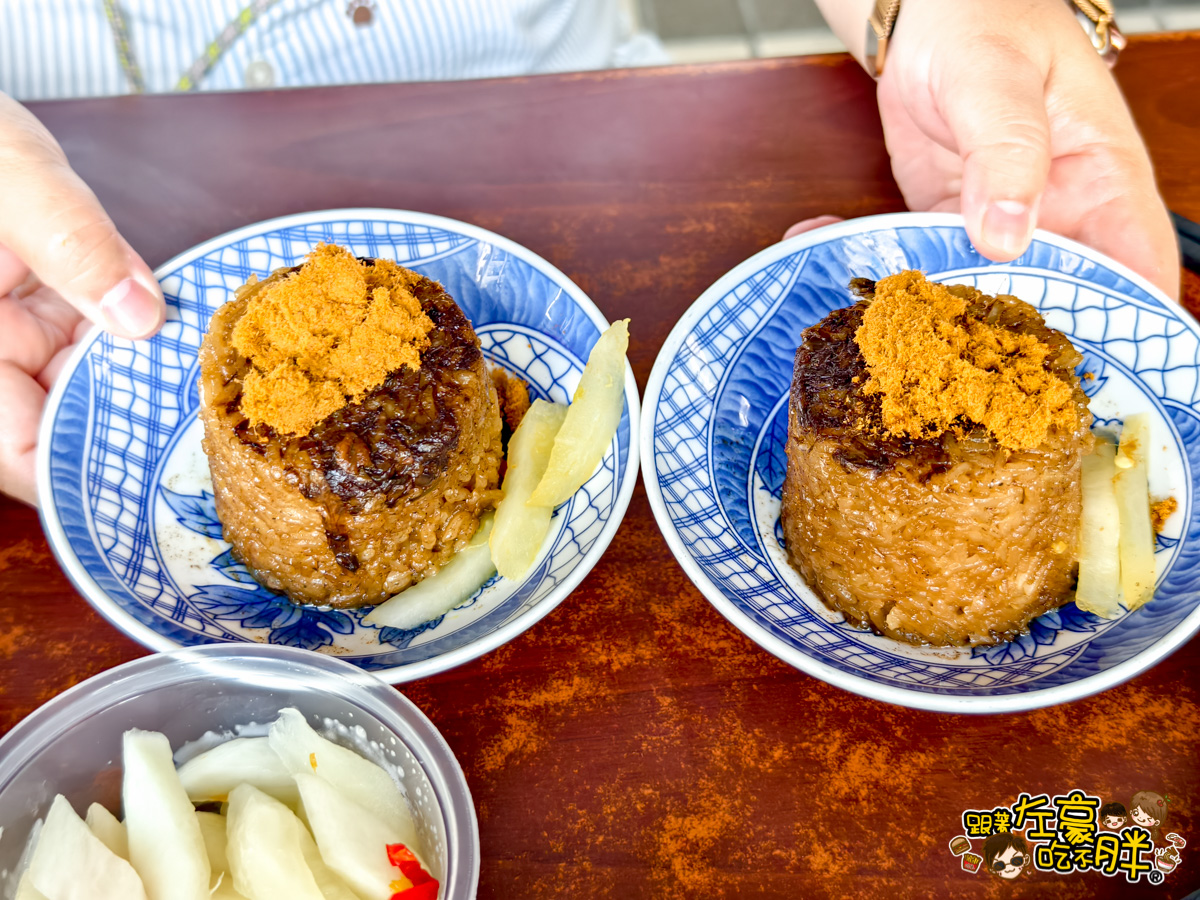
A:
[[642, 212, 1200, 713]]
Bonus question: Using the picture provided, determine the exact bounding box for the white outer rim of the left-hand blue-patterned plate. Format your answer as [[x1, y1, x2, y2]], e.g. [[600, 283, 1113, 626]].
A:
[[36, 206, 642, 684]]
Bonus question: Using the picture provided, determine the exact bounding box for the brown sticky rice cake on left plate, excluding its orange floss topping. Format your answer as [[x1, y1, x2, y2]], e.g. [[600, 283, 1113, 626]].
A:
[[199, 248, 502, 607]]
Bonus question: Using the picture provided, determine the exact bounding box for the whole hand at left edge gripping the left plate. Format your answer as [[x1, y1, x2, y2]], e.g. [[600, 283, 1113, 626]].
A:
[[0, 94, 164, 505]]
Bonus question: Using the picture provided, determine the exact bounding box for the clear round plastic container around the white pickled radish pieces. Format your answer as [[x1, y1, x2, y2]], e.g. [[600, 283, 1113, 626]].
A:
[[0, 643, 479, 900]]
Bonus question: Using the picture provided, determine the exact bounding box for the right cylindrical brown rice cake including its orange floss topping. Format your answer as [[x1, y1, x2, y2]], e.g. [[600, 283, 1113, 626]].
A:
[[781, 272, 1092, 646]]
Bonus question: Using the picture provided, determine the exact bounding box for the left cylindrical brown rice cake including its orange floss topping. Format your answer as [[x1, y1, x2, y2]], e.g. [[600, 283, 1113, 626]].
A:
[[200, 245, 500, 607]]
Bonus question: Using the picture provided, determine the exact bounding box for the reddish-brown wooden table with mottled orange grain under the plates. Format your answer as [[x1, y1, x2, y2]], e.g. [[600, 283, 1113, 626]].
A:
[[7, 34, 1200, 900]]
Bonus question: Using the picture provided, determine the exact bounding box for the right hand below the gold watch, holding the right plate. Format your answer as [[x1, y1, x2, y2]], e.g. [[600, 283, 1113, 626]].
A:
[[788, 0, 1180, 298]]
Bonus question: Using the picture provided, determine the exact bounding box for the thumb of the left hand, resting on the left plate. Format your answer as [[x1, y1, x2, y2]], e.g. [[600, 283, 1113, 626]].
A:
[[0, 95, 164, 338]]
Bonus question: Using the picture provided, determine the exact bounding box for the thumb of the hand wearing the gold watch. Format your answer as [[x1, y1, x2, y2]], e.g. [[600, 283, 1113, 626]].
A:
[[937, 44, 1050, 262]]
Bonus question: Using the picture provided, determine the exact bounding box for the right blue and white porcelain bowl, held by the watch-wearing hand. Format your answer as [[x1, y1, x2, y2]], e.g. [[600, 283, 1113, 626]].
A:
[[642, 214, 1200, 713]]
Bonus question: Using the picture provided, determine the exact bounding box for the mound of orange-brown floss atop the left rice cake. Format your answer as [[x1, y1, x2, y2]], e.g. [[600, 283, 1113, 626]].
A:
[[232, 244, 433, 434]]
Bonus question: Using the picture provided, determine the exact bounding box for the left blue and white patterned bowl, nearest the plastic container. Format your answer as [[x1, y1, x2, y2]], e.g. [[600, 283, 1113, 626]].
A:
[[38, 209, 640, 683]]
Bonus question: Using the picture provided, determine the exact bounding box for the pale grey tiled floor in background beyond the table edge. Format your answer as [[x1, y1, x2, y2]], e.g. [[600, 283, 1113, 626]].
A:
[[632, 0, 1200, 62]]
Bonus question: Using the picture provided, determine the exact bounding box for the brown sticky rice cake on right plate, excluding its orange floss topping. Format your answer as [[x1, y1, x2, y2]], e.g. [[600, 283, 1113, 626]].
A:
[[781, 274, 1092, 646]]
